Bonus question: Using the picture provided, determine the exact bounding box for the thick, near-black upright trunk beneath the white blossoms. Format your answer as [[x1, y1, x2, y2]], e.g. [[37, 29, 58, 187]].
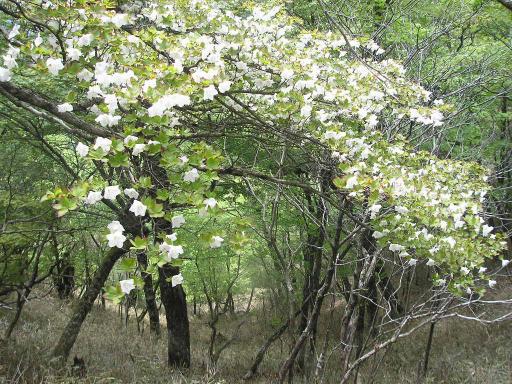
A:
[[158, 265, 190, 368]]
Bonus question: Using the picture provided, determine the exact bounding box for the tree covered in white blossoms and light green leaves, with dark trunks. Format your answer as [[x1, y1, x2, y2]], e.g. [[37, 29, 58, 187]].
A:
[[0, 0, 506, 377]]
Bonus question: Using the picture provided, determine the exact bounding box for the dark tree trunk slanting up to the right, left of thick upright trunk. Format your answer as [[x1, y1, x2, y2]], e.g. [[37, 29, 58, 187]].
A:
[[52, 248, 126, 364]]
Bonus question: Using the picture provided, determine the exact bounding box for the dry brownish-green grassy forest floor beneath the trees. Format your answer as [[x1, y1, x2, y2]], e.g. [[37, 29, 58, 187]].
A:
[[0, 284, 512, 384]]
